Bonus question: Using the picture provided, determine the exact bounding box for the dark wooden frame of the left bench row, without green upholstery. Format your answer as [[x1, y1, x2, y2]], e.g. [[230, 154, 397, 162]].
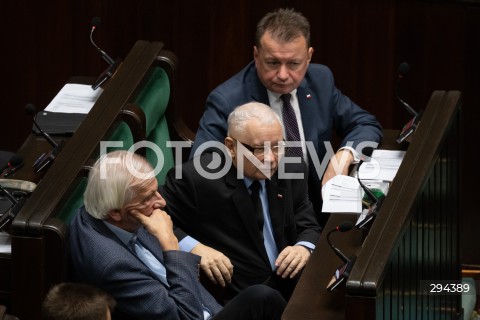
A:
[[0, 40, 182, 320]]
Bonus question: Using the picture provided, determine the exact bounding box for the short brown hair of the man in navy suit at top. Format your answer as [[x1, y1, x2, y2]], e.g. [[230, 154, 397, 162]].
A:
[[255, 9, 310, 48]]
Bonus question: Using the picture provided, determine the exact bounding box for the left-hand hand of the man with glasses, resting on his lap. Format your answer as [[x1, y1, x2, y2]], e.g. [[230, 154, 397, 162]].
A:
[[190, 243, 233, 287]]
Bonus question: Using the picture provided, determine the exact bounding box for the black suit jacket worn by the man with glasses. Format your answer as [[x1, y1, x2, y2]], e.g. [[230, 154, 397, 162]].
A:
[[163, 152, 320, 293]]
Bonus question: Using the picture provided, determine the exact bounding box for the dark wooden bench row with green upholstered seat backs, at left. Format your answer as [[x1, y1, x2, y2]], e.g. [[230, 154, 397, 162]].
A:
[[0, 40, 193, 320]]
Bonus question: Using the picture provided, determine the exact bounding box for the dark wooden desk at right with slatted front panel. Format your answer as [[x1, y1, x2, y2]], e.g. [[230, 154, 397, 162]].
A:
[[282, 91, 463, 320]]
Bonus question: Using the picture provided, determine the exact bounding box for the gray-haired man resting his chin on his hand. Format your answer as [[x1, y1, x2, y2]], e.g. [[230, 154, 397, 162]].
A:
[[70, 151, 286, 320]]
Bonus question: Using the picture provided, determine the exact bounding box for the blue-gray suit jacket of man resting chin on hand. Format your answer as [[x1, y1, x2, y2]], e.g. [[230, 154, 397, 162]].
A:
[[70, 207, 221, 320]]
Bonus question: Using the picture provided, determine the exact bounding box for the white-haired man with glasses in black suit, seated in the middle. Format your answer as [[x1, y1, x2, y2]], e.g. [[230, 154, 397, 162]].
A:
[[163, 102, 320, 300]]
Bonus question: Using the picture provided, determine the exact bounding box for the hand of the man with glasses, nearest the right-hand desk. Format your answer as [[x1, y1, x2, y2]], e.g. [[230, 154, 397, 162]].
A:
[[275, 245, 310, 278]]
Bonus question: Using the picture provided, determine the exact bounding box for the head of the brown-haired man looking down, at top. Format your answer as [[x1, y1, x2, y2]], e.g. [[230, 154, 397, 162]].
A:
[[253, 9, 313, 94]]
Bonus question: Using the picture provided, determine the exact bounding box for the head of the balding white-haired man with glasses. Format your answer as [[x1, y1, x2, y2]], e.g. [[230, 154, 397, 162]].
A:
[[225, 102, 285, 180]]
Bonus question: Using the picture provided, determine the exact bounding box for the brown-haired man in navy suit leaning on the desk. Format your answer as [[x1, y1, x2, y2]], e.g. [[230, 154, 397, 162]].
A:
[[190, 9, 383, 228]]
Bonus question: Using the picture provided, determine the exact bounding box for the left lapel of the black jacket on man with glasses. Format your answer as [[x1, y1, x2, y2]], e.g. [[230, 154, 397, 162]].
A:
[[226, 169, 270, 265]]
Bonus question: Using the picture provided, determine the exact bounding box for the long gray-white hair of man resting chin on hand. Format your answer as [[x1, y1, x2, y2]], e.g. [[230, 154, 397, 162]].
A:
[[84, 150, 155, 219]]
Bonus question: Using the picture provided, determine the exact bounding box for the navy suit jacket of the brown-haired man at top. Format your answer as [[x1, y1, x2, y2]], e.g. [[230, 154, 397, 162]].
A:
[[190, 62, 383, 225]]
